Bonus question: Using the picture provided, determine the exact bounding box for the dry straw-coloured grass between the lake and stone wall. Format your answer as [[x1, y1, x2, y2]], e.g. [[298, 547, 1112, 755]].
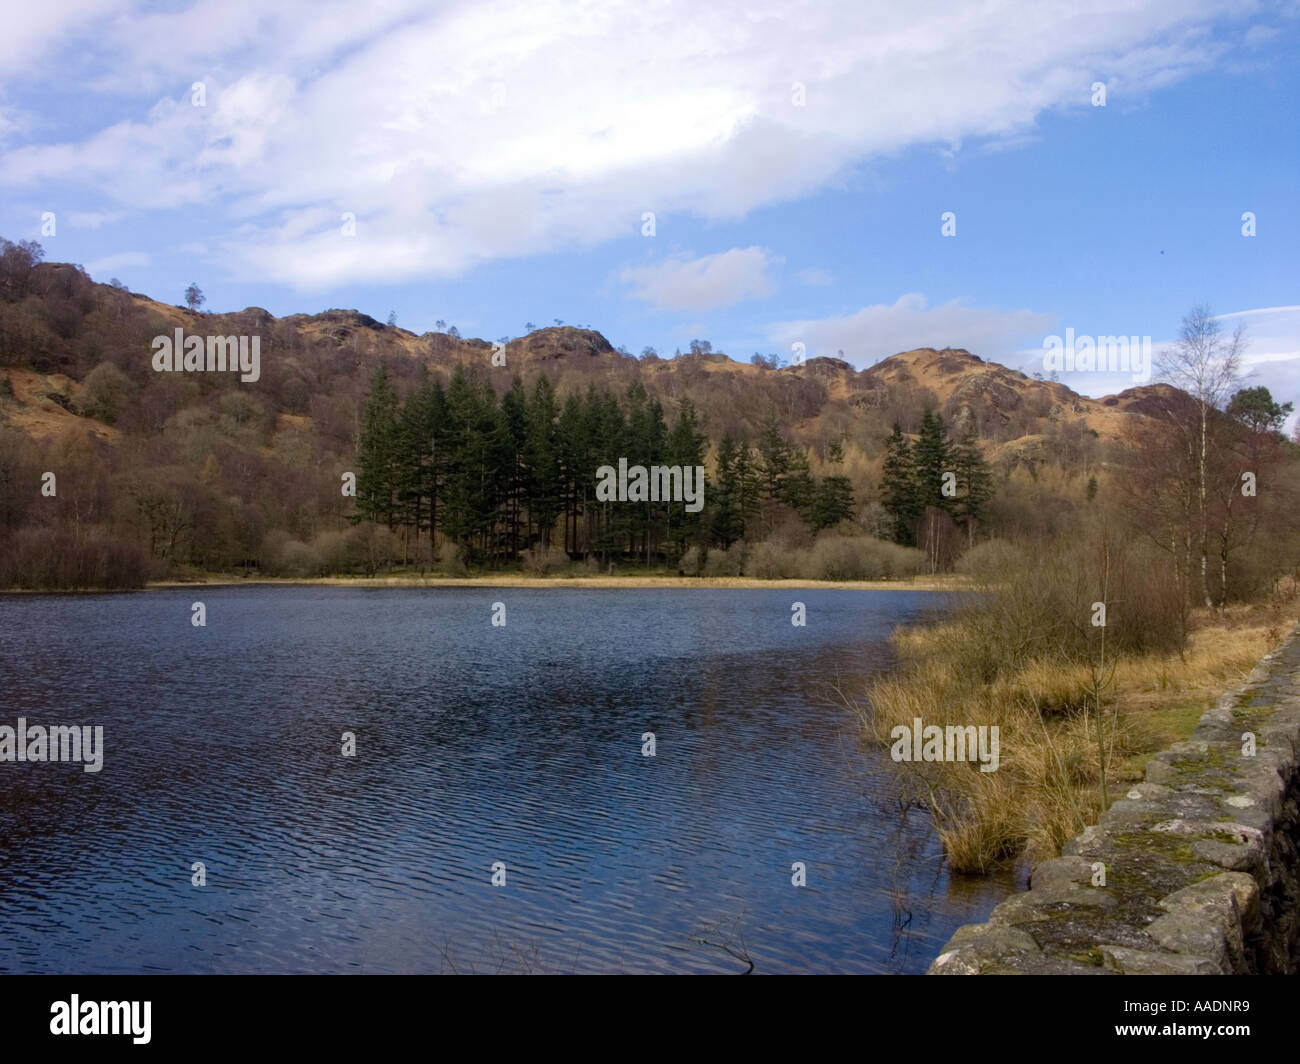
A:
[[858, 564, 1300, 874]]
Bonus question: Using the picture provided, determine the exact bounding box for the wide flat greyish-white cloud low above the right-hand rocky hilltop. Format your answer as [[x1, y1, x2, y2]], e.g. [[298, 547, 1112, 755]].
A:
[[768, 293, 1056, 369]]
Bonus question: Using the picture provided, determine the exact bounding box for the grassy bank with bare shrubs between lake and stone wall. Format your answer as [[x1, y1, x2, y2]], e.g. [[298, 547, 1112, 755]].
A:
[[859, 530, 1300, 873]]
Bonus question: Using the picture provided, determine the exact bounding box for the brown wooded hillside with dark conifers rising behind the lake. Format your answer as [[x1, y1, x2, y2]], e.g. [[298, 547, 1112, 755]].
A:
[[0, 242, 1206, 583]]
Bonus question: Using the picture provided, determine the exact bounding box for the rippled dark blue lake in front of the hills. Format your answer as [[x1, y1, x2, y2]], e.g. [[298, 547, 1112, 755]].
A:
[[0, 587, 1015, 974]]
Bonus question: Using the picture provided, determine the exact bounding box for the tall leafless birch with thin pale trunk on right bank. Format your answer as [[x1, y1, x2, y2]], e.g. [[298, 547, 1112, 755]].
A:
[[1156, 303, 1245, 609]]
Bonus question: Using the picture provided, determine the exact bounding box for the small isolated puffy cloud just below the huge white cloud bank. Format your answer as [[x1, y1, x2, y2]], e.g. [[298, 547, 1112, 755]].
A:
[[619, 247, 780, 311]]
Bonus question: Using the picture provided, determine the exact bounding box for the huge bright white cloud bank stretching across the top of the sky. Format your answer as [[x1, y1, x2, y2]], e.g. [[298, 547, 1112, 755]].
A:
[[0, 0, 1244, 287]]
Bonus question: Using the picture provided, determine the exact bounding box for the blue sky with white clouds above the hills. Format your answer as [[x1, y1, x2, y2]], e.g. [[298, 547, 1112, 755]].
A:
[[0, 0, 1300, 420]]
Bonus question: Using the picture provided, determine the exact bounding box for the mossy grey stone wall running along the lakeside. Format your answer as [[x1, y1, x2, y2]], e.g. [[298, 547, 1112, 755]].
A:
[[928, 630, 1300, 976]]
